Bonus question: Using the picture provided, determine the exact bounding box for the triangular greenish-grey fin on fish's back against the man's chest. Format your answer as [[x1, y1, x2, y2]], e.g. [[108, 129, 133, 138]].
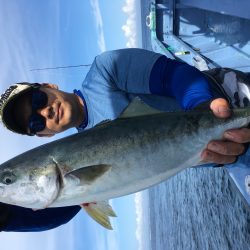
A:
[[119, 97, 163, 118]]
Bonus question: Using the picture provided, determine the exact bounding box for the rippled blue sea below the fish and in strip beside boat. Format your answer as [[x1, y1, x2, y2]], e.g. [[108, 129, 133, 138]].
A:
[[141, 0, 250, 250]]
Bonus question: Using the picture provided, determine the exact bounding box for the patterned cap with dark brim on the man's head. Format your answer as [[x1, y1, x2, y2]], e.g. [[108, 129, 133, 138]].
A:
[[0, 82, 40, 135]]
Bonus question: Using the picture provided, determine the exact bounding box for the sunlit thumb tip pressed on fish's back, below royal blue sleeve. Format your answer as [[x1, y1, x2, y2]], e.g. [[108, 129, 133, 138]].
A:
[[210, 98, 231, 118]]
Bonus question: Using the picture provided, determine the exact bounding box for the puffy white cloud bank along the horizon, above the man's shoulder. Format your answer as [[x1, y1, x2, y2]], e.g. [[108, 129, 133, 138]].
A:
[[122, 0, 140, 48]]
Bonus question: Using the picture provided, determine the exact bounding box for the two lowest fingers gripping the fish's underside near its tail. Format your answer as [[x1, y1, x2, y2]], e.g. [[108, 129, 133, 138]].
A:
[[201, 140, 245, 164]]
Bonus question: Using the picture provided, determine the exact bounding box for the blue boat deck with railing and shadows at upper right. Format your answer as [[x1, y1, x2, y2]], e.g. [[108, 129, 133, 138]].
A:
[[143, 0, 250, 72]]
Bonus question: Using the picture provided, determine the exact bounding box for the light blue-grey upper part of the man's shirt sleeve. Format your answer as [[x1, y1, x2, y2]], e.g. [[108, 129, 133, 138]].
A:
[[91, 48, 162, 94]]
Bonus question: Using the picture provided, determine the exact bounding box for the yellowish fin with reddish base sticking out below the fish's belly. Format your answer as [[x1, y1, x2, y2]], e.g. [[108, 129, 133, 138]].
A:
[[80, 201, 116, 230]]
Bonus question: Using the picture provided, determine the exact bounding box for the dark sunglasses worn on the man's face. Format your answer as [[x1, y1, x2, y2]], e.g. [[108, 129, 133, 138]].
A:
[[28, 88, 48, 135]]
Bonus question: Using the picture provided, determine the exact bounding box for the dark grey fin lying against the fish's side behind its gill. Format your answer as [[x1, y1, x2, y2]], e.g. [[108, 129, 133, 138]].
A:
[[64, 164, 111, 183]]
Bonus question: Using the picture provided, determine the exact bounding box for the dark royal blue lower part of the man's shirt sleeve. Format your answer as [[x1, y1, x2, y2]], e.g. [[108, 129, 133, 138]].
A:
[[149, 56, 214, 110]]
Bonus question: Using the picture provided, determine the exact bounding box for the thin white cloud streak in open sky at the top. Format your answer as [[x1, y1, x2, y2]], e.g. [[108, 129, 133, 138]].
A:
[[90, 0, 106, 52]]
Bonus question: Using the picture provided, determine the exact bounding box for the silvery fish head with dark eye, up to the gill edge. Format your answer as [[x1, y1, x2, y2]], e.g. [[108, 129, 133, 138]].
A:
[[0, 157, 60, 209]]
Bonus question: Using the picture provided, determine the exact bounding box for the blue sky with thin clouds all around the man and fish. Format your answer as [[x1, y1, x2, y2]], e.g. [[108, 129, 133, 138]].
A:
[[0, 0, 143, 250]]
